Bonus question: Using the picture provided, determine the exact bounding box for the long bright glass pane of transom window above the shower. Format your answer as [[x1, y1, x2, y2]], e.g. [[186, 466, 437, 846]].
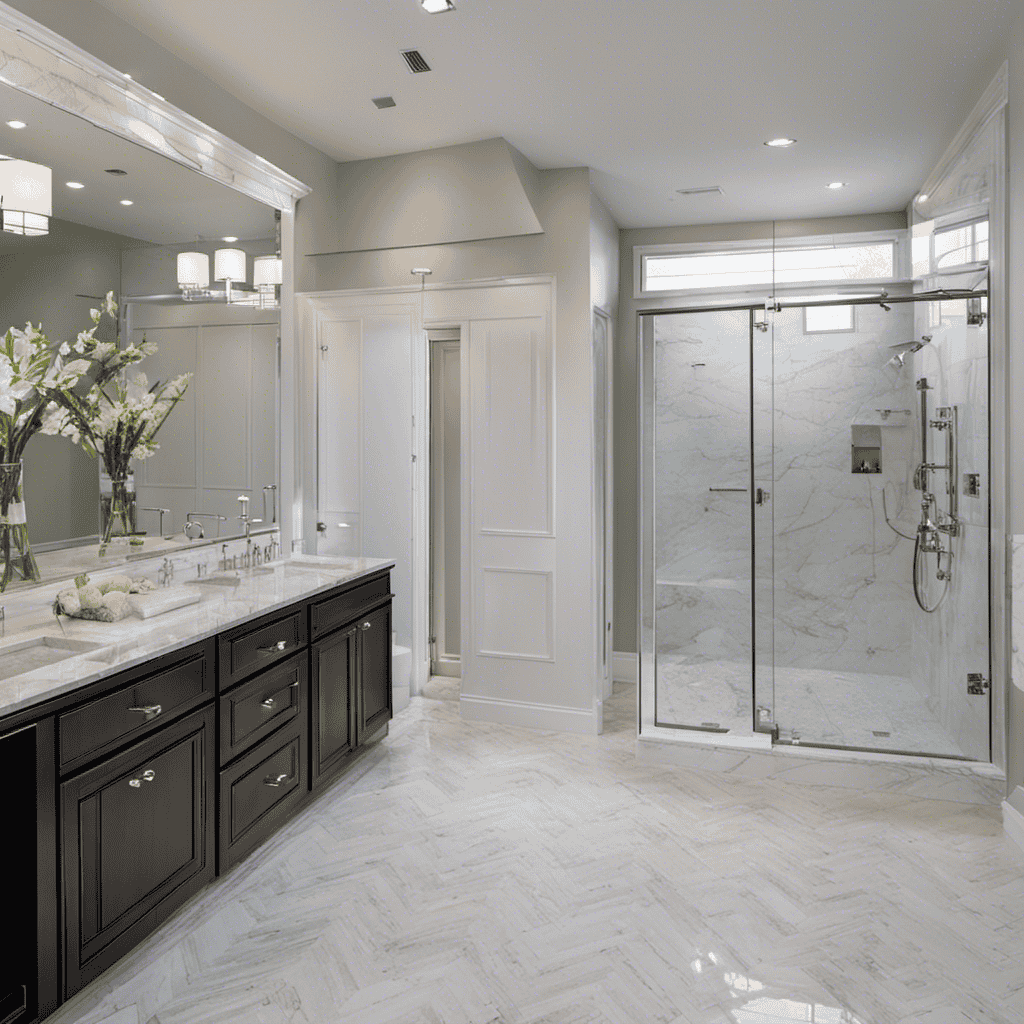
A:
[[640, 239, 896, 294]]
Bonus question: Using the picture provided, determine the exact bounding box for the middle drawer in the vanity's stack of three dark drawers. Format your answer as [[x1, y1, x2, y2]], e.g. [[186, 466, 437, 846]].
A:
[[220, 651, 307, 764]]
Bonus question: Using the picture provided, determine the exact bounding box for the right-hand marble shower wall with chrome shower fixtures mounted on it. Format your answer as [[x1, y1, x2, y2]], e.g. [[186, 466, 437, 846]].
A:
[[907, 303, 989, 761]]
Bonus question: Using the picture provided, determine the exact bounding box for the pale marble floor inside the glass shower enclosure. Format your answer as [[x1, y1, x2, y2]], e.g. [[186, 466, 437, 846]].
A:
[[657, 654, 965, 758]]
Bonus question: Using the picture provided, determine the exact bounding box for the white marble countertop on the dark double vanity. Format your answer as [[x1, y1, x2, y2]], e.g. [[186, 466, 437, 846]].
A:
[[0, 555, 394, 716]]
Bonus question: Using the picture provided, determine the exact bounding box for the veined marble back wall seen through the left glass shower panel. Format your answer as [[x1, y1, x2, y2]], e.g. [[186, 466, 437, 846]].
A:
[[654, 310, 751, 690]]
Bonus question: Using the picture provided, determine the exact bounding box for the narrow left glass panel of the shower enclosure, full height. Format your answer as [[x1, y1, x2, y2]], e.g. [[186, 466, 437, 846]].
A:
[[641, 309, 754, 734]]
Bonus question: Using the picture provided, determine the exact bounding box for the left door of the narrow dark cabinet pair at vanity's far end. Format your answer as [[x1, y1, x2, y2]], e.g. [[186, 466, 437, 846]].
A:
[[310, 627, 357, 785]]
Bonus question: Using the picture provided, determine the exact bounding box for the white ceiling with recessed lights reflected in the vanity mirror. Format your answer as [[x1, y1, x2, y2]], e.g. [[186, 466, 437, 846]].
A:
[[0, 84, 274, 249]]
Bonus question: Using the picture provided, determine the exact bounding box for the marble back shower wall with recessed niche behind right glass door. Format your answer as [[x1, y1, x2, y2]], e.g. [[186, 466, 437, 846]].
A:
[[755, 305, 915, 679]]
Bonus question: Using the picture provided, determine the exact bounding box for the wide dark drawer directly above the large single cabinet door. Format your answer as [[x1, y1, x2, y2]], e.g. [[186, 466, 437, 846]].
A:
[[57, 646, 213, 772]]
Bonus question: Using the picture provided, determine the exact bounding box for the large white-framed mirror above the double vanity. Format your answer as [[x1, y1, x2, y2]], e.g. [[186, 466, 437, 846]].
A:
[[0, 2, 308, 586]]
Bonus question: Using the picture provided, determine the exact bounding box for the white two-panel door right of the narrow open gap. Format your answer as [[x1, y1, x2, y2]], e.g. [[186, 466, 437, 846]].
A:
[[463, 303, 558, 705]]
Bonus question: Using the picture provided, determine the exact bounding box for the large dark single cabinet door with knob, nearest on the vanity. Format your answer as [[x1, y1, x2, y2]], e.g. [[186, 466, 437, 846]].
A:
[[60, 708, 215, 996]]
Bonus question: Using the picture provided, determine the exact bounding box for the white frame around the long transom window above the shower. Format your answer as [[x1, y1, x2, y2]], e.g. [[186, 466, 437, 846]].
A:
[[633, 228, 909, 300]]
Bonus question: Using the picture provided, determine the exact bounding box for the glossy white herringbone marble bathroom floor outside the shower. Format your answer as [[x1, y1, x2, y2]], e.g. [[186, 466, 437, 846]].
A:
[[50, 682, 1024, 1024]]
